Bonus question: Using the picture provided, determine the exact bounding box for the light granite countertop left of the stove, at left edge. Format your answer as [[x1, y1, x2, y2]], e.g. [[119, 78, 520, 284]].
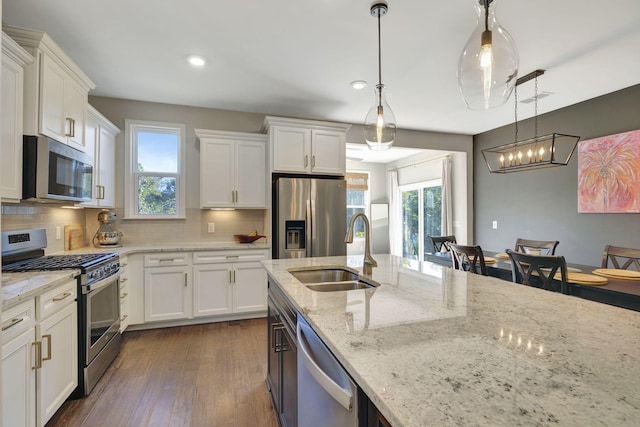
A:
[[2, 270, 80, 310]]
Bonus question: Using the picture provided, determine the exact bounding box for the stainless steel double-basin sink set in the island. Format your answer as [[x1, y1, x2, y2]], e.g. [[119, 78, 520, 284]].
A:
[[289, 267, 378, 292]]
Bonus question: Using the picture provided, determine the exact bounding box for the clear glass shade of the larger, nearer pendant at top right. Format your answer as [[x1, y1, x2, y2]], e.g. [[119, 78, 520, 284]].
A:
[[458, 0, 519, 110]]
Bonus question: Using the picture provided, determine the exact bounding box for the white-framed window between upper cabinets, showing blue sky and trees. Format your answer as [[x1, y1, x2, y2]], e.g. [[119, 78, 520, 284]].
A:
[[125, 120, 185, 219]]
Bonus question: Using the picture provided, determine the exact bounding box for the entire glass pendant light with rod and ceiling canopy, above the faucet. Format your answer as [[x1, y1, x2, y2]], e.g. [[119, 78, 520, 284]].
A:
[[364, 3, 396, 151]]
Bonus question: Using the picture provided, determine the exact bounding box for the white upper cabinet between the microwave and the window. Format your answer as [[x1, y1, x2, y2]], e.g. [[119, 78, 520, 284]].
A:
[[82, 105, 120, 208]]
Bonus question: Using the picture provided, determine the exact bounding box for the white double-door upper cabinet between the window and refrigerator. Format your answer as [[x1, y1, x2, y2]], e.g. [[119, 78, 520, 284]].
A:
[[196, 129, 268, 209]]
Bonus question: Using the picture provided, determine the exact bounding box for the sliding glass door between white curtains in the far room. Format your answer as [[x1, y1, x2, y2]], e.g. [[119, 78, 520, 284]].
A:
[[400, 179, 442, 261]]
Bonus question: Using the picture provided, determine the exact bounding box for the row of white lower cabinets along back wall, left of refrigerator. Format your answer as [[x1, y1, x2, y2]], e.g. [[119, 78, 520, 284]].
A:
[[130, 249, 269, 329]]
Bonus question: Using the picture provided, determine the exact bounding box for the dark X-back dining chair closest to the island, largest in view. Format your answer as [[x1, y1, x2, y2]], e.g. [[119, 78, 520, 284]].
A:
[[507, 249, 569, 294]]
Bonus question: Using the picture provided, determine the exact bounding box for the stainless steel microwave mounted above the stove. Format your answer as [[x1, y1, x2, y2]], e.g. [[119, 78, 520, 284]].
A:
[[22, 135, 93, 203]]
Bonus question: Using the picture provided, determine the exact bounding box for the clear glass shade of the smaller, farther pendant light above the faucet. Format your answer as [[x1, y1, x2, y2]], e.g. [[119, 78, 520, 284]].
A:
[[364, 84, 396, 151]]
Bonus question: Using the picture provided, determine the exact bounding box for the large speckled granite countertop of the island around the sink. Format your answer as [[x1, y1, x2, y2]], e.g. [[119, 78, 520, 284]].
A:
[[263, 255, 640, 427]]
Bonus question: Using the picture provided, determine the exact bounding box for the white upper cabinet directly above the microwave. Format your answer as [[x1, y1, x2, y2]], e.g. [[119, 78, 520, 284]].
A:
[[3, 26, 96, 151]]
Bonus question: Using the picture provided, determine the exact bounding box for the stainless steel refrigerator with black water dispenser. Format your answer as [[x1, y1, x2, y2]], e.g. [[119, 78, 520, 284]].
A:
[[272, 177, 347, 259]]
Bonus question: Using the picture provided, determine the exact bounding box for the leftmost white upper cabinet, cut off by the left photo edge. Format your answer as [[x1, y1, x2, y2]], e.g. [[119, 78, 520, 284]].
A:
[[0, 33, 33, 202]]
